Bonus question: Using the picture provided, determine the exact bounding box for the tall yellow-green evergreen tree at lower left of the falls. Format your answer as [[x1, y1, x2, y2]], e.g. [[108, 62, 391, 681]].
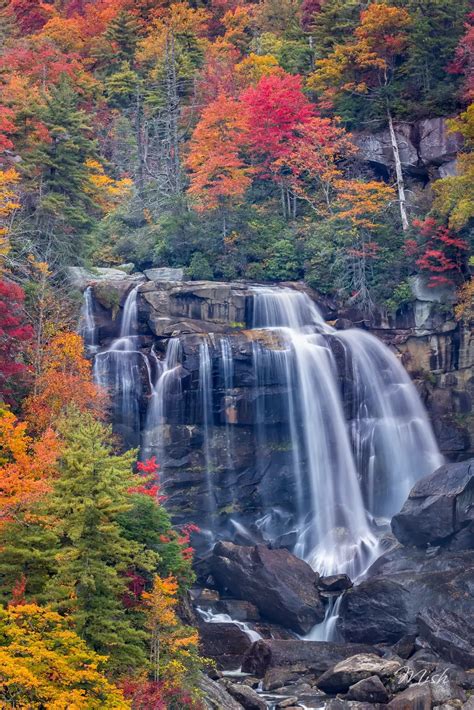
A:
[[47, 411, 156, 671]]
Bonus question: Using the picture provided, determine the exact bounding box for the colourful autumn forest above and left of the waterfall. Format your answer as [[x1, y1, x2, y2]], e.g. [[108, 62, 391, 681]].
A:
[[0, 0, 474, 710]]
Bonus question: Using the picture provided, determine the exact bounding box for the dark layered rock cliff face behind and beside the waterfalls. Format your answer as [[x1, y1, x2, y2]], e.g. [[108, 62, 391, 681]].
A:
[[79, 270, 474, 548]]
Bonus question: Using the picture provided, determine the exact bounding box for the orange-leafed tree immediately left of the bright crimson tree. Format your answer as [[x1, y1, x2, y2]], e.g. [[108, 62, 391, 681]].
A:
[[187, 95, 253, 236]]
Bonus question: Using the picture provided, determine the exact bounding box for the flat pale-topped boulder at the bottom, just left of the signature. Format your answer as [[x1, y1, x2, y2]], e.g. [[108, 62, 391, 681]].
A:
[[316, 653, 401, 699]]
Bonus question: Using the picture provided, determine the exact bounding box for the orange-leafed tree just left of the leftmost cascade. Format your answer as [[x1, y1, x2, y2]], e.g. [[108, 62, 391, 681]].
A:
[[25, 333, 105, 432]]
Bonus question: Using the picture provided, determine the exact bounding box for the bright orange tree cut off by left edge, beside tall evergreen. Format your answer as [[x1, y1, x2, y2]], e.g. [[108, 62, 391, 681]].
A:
[[0, 409, 60, 525]]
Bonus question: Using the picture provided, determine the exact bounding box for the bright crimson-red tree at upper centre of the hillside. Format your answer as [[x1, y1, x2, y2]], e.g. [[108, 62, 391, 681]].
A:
[[241, 71, 314, 172]]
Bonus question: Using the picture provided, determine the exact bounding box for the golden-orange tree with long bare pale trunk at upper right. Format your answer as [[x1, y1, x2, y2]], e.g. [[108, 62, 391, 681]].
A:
[[309, 3, 411, 231]]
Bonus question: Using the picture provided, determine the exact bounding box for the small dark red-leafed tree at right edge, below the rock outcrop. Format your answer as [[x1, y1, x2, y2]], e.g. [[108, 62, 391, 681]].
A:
[[412, 217, 468, 288]]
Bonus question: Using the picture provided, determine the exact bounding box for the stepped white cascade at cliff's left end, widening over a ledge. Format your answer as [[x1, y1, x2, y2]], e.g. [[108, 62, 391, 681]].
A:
[[93, 286, 143, 446]]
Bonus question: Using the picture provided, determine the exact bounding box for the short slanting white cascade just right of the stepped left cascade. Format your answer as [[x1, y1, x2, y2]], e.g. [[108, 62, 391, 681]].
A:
[[142, 338, 181, 465]]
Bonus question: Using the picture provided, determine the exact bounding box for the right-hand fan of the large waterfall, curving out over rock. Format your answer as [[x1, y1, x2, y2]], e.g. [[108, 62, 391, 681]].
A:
[[337, 330, 442, 517]]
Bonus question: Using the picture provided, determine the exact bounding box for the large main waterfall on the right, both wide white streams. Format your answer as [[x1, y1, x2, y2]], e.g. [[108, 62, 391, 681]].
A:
[[253, 287, 441, 579]]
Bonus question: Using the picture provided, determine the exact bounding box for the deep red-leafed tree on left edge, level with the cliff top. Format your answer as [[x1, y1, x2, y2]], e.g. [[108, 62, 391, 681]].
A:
[[0, 279, 33, 402]]
